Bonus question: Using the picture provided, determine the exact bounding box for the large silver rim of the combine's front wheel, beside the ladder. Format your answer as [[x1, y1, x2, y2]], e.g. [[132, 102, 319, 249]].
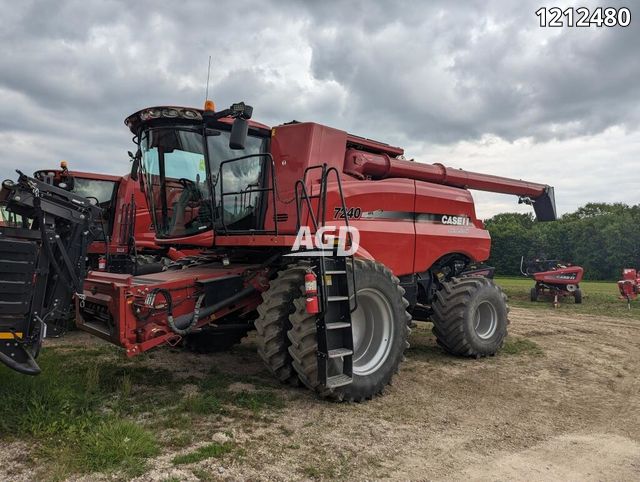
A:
[[351, 288, 393, 376]]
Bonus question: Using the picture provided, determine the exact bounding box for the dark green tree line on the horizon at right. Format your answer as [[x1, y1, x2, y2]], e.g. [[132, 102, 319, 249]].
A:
[[485, 203, 640, 280]]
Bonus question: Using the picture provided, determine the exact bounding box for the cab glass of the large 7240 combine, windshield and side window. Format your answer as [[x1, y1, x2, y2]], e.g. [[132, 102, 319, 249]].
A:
[[140, 126, 266, 238]]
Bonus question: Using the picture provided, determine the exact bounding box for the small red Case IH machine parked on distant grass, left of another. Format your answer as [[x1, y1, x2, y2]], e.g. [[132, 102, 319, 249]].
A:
[[520, 257, 584, 307]]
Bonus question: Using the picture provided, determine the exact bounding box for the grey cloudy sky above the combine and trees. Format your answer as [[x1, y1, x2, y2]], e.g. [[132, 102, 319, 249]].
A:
[[0, 0, 640, 217]]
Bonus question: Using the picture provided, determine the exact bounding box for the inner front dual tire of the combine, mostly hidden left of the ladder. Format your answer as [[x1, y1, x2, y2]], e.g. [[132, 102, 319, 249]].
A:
[[255, 265, 307, 386]]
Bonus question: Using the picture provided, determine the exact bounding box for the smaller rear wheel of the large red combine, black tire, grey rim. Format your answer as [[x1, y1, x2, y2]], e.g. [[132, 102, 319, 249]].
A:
[[432, 277, 509, 358]]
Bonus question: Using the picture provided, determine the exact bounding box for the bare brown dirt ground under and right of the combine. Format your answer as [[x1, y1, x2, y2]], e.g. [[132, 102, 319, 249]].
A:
[[2, 308, 640, 481]]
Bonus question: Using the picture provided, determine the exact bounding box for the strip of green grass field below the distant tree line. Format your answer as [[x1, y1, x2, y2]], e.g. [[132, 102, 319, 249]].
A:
[[496, 277, 640, 320]]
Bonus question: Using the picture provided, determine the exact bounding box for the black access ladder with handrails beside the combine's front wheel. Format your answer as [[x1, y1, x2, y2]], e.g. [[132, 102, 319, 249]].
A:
[[295, 164, 358, 388]]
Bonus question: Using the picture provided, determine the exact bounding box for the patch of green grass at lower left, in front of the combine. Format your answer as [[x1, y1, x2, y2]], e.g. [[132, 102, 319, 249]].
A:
[[0, 345, 284, 480]]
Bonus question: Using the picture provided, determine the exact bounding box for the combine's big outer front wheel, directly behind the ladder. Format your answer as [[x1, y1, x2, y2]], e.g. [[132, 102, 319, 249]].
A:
[[289, 260, 411, 402]]
